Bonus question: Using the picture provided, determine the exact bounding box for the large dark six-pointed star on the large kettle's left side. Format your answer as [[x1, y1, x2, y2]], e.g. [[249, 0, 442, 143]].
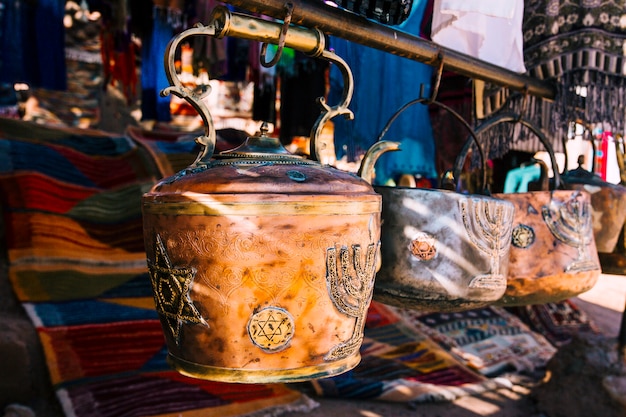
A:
[[148, 235, 209, 344]]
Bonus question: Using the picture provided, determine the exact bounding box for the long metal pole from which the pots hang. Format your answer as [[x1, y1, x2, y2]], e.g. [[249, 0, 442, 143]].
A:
[[225, 0, 556, 100]]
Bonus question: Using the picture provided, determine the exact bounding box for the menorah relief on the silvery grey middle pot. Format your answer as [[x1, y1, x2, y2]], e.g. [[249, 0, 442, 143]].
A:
[[459, 198, 515, 289]]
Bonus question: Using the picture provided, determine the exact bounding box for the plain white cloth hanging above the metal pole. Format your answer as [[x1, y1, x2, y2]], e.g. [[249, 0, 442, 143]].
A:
[[431, 0, 526, 73]]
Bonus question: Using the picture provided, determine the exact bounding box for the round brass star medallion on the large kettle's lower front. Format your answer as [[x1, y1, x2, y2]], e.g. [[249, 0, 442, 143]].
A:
[[248, 307, 294, 353]]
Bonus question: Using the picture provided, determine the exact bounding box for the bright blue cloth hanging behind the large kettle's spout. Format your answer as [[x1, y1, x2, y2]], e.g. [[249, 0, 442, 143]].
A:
[[329, 0, 437, 184]]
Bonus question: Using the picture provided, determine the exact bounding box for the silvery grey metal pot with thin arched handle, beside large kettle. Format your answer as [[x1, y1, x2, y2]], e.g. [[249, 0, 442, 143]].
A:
[[364, 99, 513, 311]]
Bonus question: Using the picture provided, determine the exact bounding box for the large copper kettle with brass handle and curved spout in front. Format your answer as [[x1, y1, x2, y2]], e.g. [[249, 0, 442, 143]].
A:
[[143, 7, 397, 383]]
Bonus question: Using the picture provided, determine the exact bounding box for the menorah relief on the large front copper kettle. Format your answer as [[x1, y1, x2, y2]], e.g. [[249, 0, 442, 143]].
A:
[[324, 243, 379, 361]]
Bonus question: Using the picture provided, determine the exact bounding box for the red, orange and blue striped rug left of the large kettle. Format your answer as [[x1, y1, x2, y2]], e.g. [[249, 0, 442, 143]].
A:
[[0, 119, 316, 417]]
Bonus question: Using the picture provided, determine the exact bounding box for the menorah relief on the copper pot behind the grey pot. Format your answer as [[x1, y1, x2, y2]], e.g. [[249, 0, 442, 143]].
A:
[[541, 192, 599, 272]]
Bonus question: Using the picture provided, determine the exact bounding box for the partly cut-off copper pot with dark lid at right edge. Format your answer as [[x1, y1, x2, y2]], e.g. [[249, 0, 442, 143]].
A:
[[561, 133, 626, 253]]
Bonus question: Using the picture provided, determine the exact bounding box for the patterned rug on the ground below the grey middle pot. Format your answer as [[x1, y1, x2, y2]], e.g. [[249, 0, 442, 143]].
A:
[[313, 302, 555, 403]]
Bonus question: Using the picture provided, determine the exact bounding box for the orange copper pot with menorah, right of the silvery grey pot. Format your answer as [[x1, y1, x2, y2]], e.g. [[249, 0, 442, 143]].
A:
[[475, 113, 601, 306]]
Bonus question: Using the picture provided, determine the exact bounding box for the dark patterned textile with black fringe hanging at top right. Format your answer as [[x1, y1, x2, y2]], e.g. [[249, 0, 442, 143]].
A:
[[484, 0, 626, 158]]
